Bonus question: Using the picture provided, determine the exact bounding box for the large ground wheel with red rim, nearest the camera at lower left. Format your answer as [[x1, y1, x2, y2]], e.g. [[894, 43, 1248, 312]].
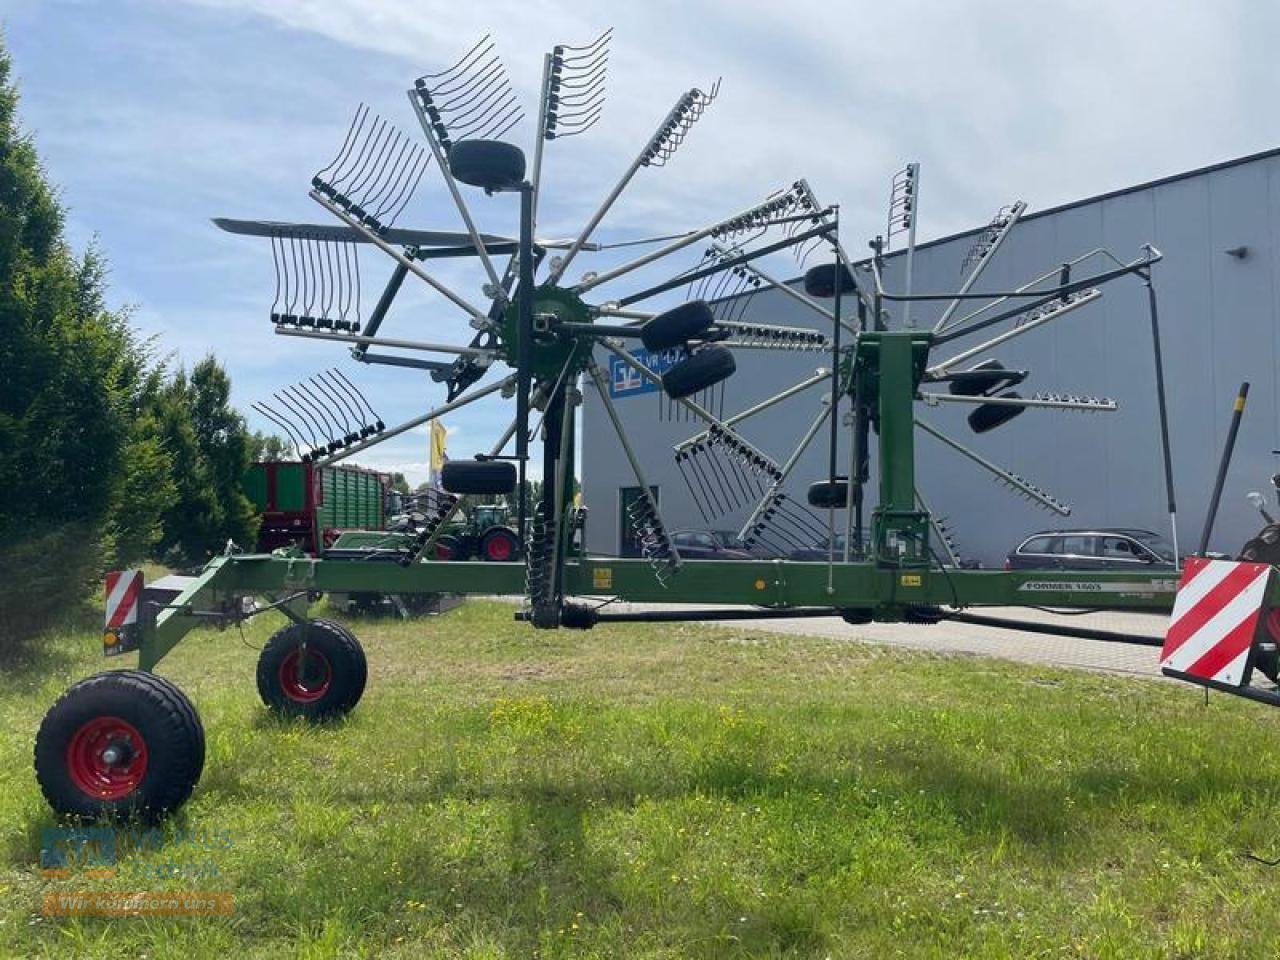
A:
[[36, 669, 205, 819]]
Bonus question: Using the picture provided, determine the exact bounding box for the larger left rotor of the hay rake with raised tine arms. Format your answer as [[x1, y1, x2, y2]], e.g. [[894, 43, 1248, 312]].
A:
[[216, 31, 851, 626]]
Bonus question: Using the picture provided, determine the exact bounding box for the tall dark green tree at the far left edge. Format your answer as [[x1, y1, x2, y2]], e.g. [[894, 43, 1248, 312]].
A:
[[0, 39, 147, 636]]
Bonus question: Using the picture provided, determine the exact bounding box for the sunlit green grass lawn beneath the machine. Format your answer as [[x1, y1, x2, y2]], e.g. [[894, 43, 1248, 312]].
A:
[[0, 603, 1280, 960]]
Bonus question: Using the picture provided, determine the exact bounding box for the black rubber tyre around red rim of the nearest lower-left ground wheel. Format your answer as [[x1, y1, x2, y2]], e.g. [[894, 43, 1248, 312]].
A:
[[35, 669, 205, 822]]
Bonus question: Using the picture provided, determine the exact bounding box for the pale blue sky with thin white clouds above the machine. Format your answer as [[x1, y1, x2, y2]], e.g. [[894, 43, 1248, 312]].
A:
[[0, 0, 1280, 480]]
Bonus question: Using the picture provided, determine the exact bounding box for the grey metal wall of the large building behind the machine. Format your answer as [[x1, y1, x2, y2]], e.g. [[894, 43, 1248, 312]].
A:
[[582, 154, 1280, 566]]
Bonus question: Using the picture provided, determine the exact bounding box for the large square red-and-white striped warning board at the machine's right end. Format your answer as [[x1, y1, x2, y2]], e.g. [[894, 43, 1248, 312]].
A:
[[1160, 557, 1272, 686]]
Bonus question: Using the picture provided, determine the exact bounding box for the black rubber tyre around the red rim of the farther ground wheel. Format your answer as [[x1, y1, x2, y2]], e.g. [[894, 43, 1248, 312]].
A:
[[257, 620, 369, 722]]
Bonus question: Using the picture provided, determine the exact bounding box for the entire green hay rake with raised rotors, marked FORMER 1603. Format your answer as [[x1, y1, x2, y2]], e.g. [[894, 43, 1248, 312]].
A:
[[36, 32, 1275, 817]]
